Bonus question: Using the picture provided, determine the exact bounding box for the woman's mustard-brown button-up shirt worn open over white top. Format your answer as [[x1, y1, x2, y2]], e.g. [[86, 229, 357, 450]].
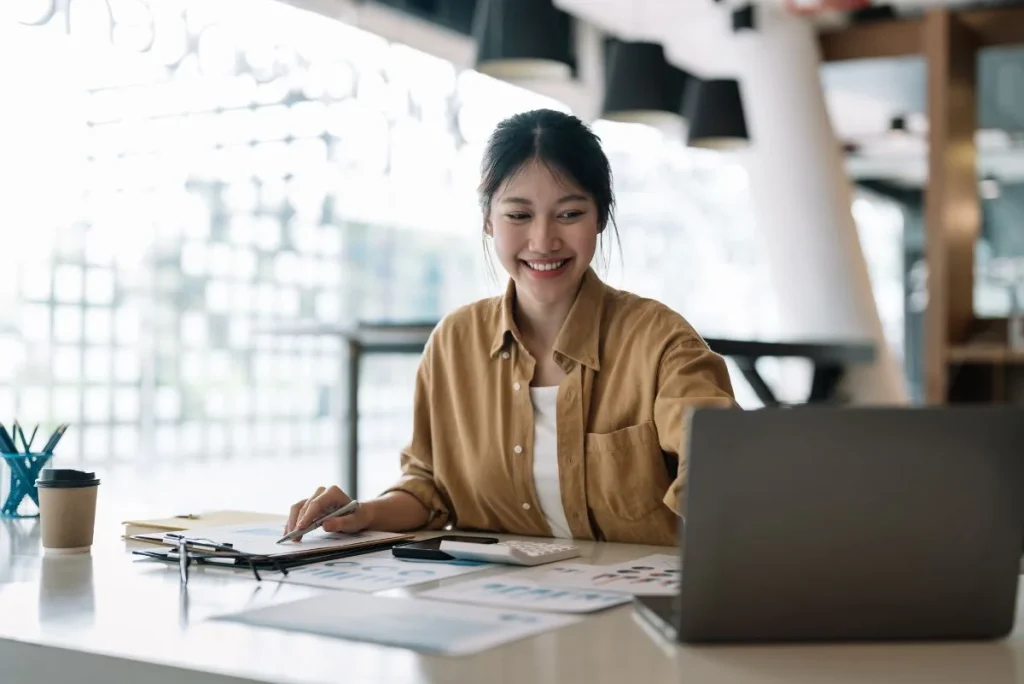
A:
[[389, 270, 735, 545]]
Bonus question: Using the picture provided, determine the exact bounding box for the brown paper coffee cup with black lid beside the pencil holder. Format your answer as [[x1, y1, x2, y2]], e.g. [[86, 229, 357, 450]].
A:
[[36, 468, 99, 554]]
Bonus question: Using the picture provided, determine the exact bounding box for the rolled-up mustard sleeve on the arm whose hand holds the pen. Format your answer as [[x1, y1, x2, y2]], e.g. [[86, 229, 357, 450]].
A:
[[384, 342, 452, 529]]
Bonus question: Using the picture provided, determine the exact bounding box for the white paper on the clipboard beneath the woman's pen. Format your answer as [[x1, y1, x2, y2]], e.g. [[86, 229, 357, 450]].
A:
[[141, 524, 404, 556]]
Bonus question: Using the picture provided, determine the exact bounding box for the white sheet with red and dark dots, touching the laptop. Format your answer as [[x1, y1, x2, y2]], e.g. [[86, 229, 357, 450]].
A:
[[529, 554, 680, 596]]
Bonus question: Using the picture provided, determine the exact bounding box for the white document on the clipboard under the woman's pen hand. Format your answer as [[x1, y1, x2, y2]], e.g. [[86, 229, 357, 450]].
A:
[[131, 523, 414, 559]]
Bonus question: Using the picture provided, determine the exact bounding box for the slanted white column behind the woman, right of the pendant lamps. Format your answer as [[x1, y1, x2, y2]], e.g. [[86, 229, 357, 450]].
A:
[[729, 3, 907, 404]]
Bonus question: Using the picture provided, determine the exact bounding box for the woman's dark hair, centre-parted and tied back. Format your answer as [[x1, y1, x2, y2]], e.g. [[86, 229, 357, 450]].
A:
[[478, 110, 618, 266]]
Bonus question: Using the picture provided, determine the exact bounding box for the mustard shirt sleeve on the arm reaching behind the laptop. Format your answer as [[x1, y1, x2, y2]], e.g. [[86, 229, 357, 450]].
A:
[[654, 338, 738, 516]]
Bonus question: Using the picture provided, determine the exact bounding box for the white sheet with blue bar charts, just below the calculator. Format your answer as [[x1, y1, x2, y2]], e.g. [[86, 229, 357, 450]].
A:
[[418, 576, 633, 612]]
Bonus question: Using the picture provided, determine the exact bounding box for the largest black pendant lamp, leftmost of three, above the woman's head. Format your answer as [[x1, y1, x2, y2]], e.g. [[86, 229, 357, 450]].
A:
[[473, 0, 575, 81]]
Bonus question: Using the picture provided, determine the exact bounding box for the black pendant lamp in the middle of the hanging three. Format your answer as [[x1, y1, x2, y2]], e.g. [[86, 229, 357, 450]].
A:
[[601, 39, 689, 133]]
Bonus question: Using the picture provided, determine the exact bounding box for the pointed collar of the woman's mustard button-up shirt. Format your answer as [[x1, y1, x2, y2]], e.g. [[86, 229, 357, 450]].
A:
[[490, 268, 607, 371]]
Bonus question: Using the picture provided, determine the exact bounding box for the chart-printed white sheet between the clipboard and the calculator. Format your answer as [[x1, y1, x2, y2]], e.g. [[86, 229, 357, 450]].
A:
[[266, 551, 492, 592]]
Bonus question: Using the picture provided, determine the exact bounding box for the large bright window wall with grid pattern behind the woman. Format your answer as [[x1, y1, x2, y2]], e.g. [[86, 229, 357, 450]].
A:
[[0, 0, 901, 493]]
